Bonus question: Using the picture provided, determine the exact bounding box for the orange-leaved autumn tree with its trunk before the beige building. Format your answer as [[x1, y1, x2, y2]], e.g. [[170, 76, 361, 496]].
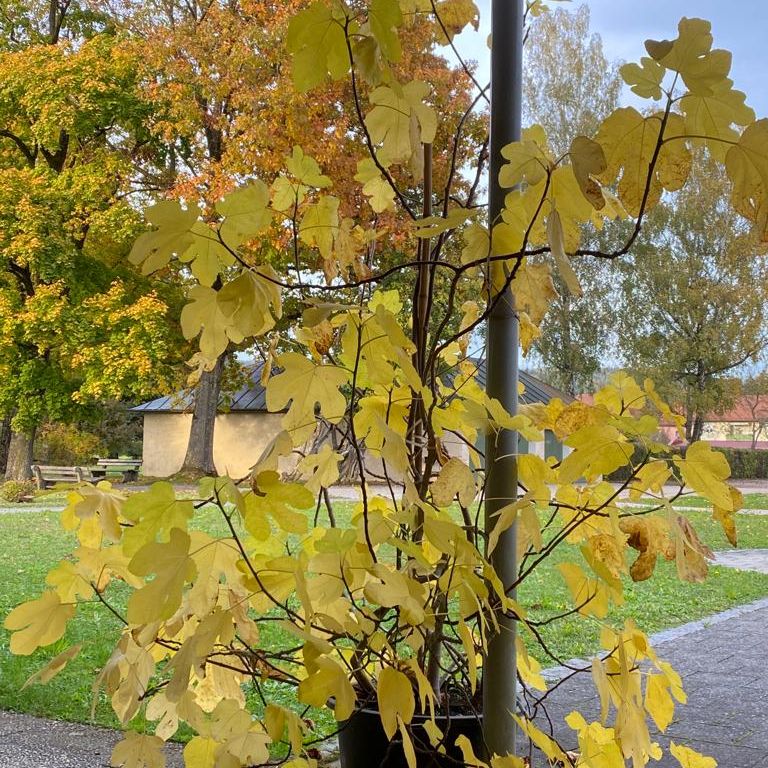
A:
[[118, 0, 487, 474]]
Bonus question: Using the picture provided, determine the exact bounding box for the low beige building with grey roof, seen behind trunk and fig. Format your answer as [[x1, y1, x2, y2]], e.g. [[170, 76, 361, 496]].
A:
[[132, 365, 573, 477]]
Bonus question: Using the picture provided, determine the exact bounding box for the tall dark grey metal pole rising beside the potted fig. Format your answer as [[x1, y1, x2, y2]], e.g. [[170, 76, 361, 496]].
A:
[[483, 0, 524, 755]]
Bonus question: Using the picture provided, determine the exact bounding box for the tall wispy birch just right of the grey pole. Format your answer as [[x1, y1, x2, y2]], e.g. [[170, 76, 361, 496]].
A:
[[523, 5, 622, 395]]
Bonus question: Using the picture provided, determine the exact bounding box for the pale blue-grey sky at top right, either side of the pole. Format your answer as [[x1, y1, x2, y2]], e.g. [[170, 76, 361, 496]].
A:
[[462, 0, 768, 117]]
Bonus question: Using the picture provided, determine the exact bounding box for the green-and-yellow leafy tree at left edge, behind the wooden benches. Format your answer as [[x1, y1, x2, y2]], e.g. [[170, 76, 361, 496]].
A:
[[0, 2, 178, 476]]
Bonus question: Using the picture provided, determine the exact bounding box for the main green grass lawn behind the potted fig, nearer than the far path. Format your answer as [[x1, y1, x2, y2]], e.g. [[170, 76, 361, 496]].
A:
[[0, 505, 768, 726]]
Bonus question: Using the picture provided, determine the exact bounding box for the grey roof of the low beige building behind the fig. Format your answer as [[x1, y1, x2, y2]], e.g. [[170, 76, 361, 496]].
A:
[[131, 361, 573, 413]]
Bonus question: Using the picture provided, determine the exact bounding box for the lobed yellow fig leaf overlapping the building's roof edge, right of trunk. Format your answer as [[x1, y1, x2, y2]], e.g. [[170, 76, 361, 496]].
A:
[[267, 352, 349, 445]]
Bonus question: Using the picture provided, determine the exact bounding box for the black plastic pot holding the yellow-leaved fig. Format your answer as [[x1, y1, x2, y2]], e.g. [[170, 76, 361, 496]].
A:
[[339, 709, 485, 768]]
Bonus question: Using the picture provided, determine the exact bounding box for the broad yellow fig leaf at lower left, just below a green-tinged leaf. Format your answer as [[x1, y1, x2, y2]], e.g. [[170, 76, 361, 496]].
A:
[[127, 528, 197, 624]]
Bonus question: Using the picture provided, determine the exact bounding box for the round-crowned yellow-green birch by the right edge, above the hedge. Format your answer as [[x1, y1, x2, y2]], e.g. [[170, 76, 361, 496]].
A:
[[617, 151, 768, 441]]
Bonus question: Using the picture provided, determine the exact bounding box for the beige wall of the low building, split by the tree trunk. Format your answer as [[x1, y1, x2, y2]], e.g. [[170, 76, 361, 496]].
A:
[[142, 412, 282, 478]]
